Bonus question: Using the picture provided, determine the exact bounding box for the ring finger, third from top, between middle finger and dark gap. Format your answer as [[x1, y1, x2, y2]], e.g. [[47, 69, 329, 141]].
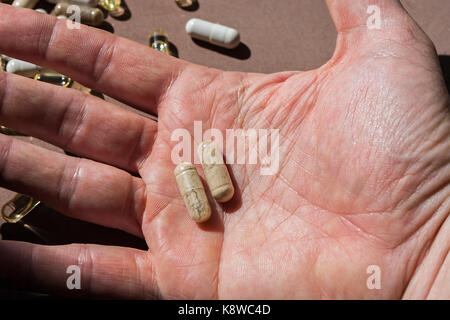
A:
[[0, 135, 145, 236]]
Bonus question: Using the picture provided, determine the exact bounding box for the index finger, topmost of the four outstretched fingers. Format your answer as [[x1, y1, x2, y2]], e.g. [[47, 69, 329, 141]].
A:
[[0, 4, 191, 113]]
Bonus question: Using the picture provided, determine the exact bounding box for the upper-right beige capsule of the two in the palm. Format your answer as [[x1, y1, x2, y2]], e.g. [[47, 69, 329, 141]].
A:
[[198, 140, 234, 202]]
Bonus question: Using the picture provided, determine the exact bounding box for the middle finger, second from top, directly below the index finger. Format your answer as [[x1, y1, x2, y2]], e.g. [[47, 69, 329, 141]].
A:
[[0, 72, 157, 172]]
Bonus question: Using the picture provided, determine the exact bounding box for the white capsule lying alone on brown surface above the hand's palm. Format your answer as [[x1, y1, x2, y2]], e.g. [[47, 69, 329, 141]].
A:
[[186, 18, 241, 49]]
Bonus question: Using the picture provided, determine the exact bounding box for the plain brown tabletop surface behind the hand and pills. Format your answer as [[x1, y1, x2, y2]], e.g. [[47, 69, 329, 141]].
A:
[[0, 0, 450, 247]]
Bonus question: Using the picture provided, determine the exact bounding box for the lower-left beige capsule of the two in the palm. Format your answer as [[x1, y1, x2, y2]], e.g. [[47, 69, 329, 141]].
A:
[[174, 162, 211, 222]]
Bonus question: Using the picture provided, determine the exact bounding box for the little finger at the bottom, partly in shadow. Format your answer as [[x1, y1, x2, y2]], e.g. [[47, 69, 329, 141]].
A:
[[0, 240, 157, 299]]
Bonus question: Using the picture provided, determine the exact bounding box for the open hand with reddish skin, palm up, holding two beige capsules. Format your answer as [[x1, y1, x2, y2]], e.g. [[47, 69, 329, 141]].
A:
[[0, 0, 450, 298]]
